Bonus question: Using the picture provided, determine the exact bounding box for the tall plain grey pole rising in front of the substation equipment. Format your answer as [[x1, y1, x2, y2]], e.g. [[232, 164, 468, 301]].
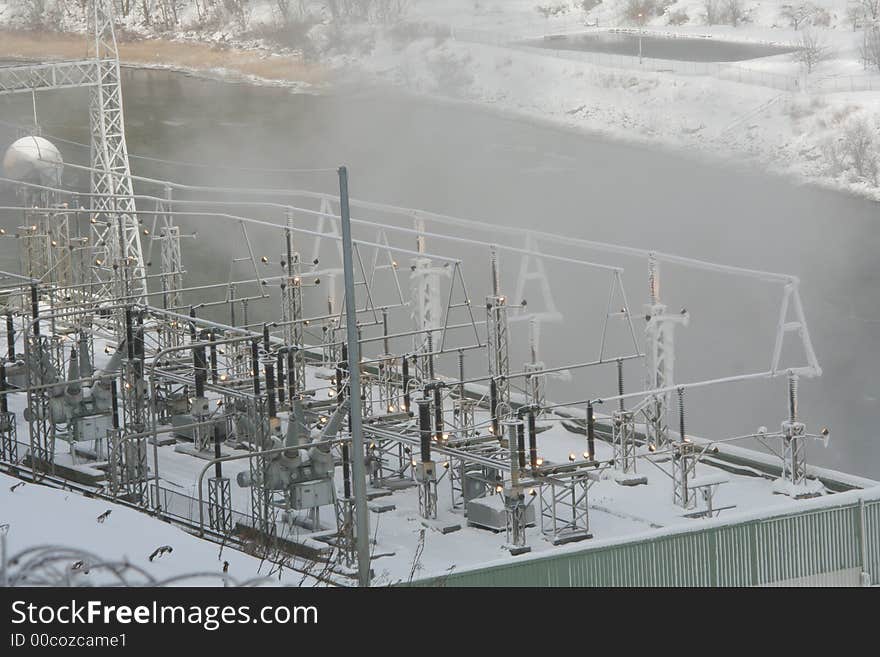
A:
[[339, 167, 370, 586]]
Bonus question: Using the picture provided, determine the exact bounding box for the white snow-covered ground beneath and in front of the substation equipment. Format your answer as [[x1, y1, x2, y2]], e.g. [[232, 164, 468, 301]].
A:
[[0, 326, 873, 585]]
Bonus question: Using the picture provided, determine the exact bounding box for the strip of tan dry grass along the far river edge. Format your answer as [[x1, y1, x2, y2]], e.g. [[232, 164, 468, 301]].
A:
[[0, 31, 326, 84]]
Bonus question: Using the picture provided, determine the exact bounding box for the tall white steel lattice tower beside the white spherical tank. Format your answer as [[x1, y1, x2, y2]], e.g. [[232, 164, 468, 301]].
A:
[[89, 0, 147, 302]]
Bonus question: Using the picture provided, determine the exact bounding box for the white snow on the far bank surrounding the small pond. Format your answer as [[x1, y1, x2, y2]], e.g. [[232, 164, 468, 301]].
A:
[[348, 1, 880, 197]]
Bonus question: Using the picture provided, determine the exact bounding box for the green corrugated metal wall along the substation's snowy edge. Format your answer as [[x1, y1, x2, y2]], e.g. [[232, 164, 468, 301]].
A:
[[412, 489, 880, 587]]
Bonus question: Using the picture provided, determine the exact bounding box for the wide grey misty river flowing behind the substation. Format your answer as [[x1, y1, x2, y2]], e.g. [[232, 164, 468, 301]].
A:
[[0, 71, 880, 477]]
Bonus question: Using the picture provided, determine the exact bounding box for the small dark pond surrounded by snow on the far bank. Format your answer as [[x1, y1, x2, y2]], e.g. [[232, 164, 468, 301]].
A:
[[527, 32, 794, 62]]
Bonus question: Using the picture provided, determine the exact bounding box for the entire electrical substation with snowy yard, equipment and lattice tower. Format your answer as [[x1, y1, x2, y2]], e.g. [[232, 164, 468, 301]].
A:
[[0, 0, 872, 584]]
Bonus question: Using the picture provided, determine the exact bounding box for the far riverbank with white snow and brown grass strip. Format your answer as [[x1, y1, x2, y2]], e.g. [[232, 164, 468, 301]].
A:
[[0, 0, 880, 198]]
